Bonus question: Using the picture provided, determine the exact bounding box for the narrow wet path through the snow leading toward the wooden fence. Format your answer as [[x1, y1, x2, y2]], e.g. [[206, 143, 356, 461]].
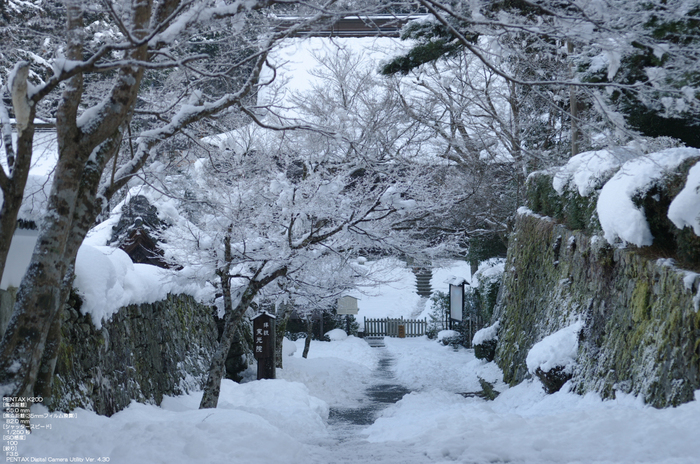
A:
[[310, 343, 435, 464]]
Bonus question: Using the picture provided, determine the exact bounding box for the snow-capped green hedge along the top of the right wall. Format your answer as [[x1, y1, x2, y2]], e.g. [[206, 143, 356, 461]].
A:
[[532, 147, 700, 267]]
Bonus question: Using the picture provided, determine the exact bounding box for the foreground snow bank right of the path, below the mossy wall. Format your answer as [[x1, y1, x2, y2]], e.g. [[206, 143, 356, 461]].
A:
[[363, 376, 700, 464]]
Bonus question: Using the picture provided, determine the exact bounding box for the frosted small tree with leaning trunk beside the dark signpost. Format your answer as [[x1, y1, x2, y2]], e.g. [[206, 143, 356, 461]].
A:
[[157, 41, 459, 407]]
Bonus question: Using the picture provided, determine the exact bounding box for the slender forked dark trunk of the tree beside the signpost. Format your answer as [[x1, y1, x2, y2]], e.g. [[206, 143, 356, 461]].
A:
[[199, 264, 287, 409]]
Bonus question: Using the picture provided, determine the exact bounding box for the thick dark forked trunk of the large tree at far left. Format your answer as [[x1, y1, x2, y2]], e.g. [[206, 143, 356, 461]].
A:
[[0, 2, 148, 414]]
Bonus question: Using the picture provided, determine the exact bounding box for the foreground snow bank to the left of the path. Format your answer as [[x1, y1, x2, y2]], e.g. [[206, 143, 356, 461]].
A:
[[20, 380, 328, 464]]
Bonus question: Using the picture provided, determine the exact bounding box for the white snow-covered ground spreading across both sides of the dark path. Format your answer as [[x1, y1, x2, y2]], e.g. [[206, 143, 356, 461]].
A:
[[18, 337, 700, 464]]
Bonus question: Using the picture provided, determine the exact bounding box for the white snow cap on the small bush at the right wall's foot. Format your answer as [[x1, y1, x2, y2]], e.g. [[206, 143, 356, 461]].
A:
[[525, 321, 583, 374]]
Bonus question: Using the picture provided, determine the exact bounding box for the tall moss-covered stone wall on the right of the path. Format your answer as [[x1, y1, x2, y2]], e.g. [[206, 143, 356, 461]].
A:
[[494, 213, 700, 407]]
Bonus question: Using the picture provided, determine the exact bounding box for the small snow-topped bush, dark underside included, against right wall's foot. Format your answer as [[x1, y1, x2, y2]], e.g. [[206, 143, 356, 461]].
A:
[[525, 321, 583, 393]]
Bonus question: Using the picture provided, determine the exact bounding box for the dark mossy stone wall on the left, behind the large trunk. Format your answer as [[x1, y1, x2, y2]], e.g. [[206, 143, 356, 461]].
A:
[[49, 295, 218, 415]]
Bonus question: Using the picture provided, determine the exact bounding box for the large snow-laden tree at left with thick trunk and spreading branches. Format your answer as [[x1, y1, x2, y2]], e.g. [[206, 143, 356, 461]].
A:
[[0, 0, 400, 414]]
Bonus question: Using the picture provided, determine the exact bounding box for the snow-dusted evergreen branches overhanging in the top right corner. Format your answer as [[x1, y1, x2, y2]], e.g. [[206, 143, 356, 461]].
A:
[[404, 0, 700, 144]]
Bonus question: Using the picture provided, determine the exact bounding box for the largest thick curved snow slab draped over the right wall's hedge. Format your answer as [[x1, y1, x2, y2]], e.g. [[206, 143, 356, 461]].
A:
[[597, 148, 700, 246]]
